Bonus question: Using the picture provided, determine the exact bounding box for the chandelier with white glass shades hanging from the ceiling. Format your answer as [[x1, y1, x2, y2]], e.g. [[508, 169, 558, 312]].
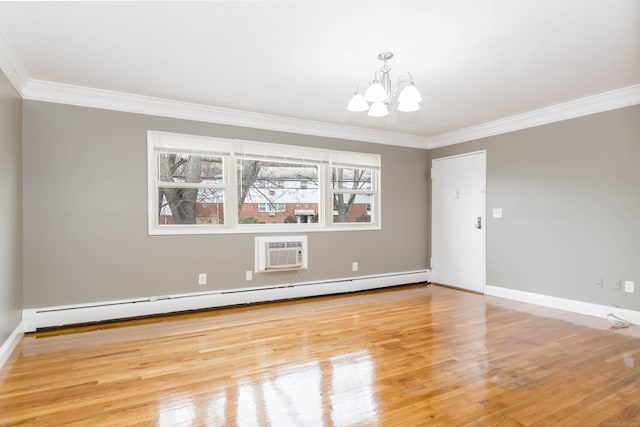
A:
[[347, 52, 422, 117]]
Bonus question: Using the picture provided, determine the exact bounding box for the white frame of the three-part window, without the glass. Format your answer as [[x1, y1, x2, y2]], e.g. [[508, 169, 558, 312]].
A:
[[147, 131, 382, 235]]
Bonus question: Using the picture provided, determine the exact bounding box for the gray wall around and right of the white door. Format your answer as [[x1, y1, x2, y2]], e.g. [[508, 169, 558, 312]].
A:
[[430, 106, 640, 310]]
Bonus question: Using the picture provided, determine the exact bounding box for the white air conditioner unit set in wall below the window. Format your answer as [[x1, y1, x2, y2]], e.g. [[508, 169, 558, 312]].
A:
[[255, 236, 308, 273]]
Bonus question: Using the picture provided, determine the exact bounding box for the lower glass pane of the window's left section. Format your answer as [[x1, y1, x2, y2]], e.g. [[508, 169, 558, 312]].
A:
[[158, 187, 224, 225]]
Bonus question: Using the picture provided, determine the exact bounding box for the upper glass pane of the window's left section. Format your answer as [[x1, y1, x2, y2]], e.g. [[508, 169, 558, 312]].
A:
[[158, 153, 224, 183]]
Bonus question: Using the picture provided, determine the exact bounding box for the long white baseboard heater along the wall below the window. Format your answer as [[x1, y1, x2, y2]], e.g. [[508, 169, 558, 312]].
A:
[[22, 270, 431, 332]]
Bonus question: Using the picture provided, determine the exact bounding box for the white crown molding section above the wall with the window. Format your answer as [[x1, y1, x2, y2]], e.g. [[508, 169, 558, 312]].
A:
[[23, 79, 428, 149]]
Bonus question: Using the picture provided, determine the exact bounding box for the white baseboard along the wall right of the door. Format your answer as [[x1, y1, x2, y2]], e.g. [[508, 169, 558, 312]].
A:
[[484, 285, 640, 325]]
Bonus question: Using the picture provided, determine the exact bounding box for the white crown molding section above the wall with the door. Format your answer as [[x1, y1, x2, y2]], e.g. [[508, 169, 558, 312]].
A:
[[426, 84, 640, 149]]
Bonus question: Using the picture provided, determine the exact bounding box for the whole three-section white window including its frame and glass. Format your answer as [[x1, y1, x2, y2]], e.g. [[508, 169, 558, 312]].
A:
[[147, 131, 380, 234]]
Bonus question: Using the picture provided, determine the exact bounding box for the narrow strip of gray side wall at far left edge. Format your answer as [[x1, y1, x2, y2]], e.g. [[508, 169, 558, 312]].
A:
[[0, 71, 22, 344]]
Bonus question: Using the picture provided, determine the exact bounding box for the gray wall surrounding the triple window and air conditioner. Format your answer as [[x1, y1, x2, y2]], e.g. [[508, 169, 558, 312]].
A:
[[23, 101, 429, 308]]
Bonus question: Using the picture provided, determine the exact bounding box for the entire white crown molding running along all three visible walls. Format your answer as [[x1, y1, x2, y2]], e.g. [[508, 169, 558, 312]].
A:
[[5, 41, 640, 149]]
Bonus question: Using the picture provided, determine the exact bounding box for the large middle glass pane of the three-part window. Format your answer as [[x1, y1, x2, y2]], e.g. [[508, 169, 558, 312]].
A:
[[238, 159, 320, 224]]
